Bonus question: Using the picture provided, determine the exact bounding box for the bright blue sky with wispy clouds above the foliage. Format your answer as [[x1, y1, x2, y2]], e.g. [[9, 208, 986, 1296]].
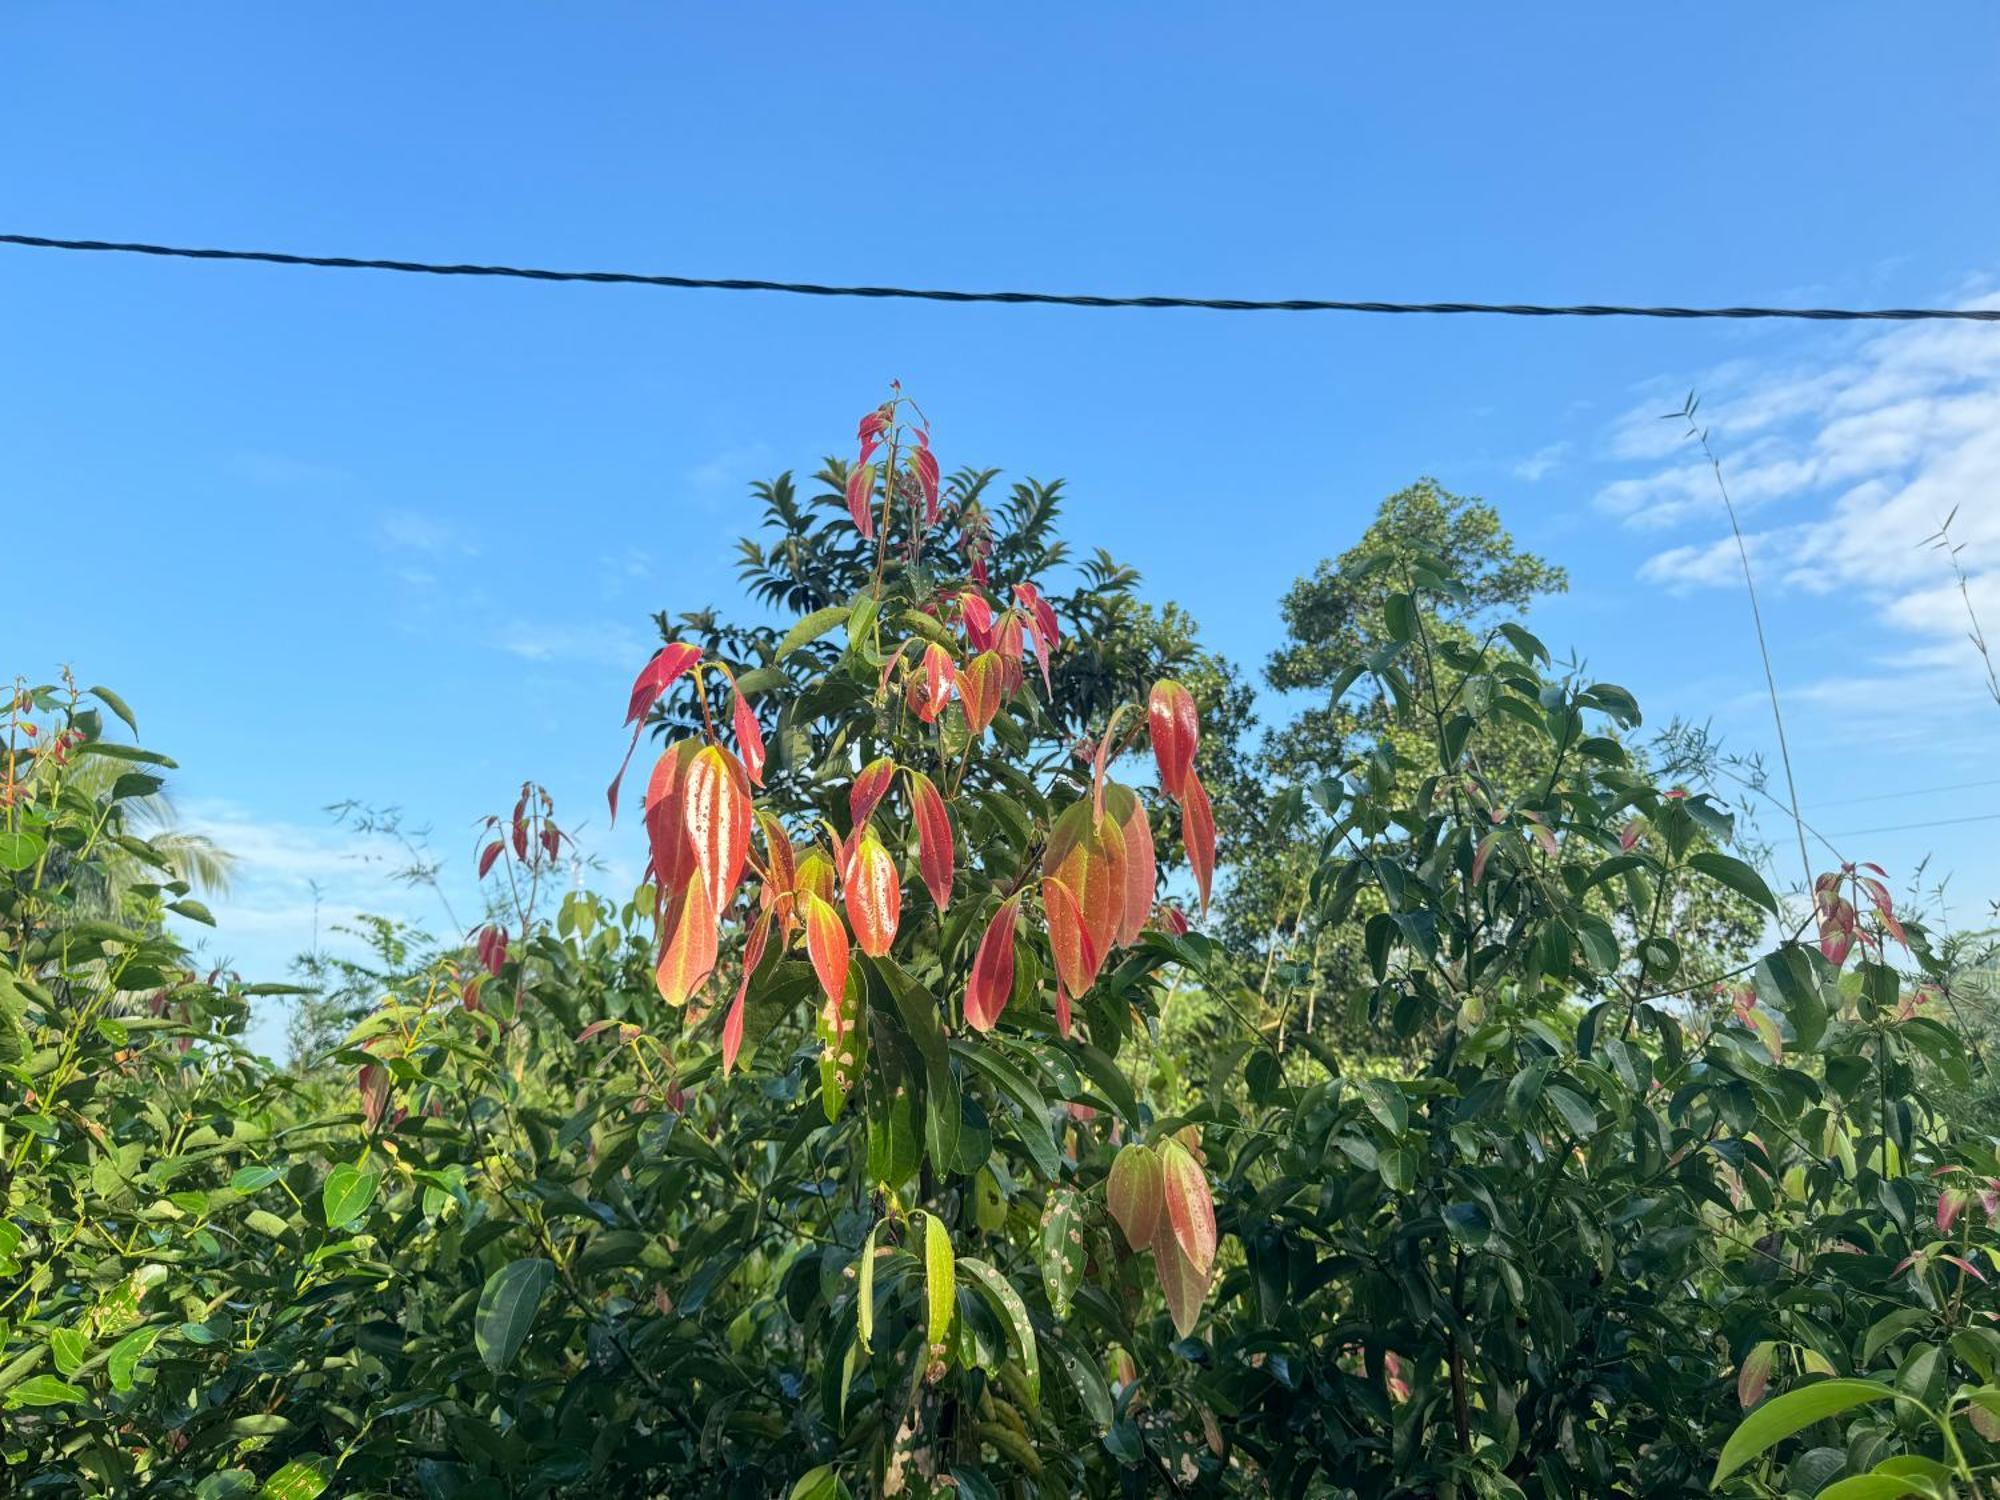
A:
[[0, 0, 2000, 1034]]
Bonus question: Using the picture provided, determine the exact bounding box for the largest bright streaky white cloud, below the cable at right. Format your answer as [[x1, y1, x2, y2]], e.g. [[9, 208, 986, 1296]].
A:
[[1596, 294, 2000, 714]]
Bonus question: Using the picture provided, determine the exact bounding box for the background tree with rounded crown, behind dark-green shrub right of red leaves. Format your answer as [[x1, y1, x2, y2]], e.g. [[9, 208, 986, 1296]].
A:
[[1220, 478, 1762, 1052]]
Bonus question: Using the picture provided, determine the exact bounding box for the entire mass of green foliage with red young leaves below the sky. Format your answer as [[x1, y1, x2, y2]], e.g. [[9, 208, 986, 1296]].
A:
[[0, 404, 2000, 1500]]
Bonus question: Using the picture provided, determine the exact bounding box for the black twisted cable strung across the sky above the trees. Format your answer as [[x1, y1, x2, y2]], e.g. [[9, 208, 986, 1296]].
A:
[[11, 234, 2000, 322]]
